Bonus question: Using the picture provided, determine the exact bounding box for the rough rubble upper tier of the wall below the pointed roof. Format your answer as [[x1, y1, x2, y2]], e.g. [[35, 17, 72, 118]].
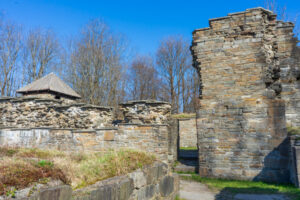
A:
[[0, 97, 113, 129]]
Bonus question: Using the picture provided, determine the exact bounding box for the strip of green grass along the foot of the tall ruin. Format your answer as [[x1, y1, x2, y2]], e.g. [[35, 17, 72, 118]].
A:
[[182, 174, 300, 199]]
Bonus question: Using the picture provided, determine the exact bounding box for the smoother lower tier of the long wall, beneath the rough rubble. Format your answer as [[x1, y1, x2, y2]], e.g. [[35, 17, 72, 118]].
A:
[[0, 124, 175, 162]]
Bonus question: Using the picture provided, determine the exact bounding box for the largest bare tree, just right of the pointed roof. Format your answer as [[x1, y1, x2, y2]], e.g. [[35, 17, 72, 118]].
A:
[[67, 20, 126, 105]]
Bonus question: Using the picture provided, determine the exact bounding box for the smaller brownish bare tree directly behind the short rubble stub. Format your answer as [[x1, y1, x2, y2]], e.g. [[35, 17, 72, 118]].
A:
[[130, 56, 160, 100]]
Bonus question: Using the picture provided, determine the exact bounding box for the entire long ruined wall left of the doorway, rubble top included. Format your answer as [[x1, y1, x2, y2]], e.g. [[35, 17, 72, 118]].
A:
[[0, 97, 177, 162]]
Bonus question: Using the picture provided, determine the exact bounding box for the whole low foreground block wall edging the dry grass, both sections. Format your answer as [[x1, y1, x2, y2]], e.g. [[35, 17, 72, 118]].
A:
[[0, 162, 179, 200]]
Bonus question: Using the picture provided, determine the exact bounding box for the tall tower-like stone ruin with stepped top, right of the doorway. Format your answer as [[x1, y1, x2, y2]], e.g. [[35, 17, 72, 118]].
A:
[[191, 8, 295, 182]]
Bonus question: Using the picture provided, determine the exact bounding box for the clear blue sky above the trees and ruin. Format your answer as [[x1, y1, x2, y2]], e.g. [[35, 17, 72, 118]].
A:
[[0, 0, 300, 54]]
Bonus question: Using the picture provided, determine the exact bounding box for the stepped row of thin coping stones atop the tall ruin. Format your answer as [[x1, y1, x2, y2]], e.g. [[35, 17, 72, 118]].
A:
[[193, 7, 294, 34]]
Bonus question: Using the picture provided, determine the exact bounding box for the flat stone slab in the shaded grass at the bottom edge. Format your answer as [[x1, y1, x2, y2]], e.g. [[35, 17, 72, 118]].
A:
[[234, 194, 290, 200]]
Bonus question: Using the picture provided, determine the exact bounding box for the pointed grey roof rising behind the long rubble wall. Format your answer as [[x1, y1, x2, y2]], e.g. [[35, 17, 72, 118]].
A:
[[17, 73, 81, 98]]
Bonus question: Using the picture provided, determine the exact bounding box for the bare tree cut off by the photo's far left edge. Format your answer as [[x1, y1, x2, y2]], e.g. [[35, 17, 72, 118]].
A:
[[0, 21, 21, 96]]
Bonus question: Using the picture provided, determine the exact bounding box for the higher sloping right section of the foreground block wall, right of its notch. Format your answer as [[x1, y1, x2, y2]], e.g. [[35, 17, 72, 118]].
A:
[[73, 162, 179, 200]]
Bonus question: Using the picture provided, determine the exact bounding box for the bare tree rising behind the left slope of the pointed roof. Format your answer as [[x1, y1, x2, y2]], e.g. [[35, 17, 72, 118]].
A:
[[22, 29, 59, 83]]
